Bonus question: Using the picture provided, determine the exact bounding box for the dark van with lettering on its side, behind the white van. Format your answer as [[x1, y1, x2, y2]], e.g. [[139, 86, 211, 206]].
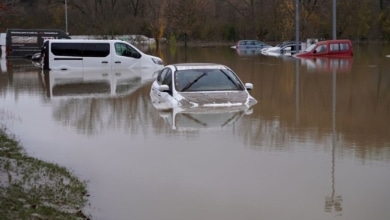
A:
[[6, 29, 70, 58]]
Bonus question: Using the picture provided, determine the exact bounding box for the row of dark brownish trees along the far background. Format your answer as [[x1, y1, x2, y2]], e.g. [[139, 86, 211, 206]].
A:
[[0, 0, 390, 45]]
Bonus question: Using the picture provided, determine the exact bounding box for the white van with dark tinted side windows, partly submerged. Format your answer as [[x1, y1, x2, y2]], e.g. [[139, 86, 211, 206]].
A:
[[41, 39, 164, 70]]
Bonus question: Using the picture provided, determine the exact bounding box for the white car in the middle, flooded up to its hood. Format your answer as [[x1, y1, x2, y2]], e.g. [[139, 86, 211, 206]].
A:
[[150, 63, 257, 110]]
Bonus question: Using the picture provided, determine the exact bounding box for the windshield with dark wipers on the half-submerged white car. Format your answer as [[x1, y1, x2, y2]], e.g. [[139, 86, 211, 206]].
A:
[[175, 69, 244, 92]]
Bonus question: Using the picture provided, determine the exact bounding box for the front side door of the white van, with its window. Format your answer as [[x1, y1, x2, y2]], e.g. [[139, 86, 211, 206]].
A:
[[112, 42, 142, 70]]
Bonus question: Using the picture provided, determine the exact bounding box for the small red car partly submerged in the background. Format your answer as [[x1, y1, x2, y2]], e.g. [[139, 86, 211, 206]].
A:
[[294, 39, 353, 57]]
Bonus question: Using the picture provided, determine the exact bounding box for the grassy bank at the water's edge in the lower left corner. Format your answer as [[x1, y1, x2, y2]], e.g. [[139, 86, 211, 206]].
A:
[[0, 129, 89, 220]]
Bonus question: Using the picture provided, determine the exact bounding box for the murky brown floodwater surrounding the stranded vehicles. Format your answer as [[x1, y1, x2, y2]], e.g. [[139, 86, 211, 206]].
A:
[[0, 44, 390, 220]]
